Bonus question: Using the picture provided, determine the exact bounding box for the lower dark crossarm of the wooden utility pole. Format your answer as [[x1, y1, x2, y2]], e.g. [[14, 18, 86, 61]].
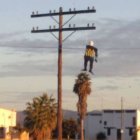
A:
[[31, 26, 96, 33]]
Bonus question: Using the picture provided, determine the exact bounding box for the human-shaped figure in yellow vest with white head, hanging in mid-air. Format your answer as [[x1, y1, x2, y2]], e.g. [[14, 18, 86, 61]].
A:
[[83, 41, 98, 74]]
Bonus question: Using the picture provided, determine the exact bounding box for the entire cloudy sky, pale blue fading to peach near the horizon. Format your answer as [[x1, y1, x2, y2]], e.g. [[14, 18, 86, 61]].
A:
[[0, 0, 140, 110]]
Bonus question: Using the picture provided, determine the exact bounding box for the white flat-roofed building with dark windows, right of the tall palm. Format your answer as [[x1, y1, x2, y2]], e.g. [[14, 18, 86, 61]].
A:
[[85, 110, 140, 140]]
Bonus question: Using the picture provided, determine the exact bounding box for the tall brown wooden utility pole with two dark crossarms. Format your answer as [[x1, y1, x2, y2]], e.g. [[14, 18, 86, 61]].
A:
[[31, 7, 96, 140]]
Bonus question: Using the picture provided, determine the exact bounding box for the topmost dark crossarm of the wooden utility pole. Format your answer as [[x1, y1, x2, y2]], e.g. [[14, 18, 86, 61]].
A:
[[31, 8, 96, 18]]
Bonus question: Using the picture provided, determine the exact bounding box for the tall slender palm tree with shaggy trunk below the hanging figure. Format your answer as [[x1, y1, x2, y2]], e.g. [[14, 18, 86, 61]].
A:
[[73, 73, 91, 140]]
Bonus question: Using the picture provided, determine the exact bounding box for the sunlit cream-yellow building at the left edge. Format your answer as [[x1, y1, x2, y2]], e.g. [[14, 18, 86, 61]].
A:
[[0, 108, 16, 138]]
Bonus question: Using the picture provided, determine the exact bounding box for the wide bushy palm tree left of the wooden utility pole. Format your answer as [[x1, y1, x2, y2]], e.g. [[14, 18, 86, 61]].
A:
[[24, 93, 57, 140]]
